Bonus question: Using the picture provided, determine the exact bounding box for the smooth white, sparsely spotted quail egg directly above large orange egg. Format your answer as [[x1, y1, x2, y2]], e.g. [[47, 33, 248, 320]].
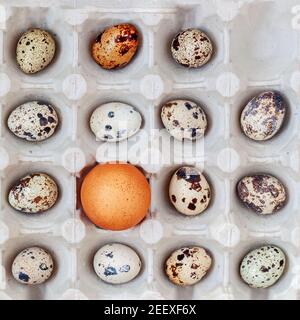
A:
[[90, 102, 142, 142]]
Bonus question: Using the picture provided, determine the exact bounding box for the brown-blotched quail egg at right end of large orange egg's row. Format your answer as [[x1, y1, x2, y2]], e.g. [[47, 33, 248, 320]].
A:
[[237, 174, 287, 215]]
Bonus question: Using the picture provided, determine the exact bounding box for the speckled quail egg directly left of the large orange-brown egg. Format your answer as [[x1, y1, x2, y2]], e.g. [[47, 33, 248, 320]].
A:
[[8, 173, 58, 213]]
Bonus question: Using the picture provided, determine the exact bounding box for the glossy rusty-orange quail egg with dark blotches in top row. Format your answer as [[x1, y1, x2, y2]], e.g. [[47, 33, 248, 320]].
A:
[[92, 23, 139, 69]]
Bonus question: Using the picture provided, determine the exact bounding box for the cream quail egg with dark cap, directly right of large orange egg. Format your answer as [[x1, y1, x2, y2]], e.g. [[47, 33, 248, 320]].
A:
[[169, 167, 211, 216]]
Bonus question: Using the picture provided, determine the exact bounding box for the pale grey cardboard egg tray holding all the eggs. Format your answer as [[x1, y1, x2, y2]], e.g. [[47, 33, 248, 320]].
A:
[[0, 0, 300, 299]]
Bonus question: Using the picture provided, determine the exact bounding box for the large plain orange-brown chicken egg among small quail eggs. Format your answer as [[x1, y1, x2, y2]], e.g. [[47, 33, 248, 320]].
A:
[[81, 163, 151, 230]]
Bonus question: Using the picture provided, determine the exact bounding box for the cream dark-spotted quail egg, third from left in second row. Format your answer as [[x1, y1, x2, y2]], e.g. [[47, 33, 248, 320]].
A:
[[161, 100, 207, 140]]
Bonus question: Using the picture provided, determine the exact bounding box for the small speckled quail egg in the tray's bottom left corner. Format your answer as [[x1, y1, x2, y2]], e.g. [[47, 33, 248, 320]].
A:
[[12, 247, 54, 285]]
